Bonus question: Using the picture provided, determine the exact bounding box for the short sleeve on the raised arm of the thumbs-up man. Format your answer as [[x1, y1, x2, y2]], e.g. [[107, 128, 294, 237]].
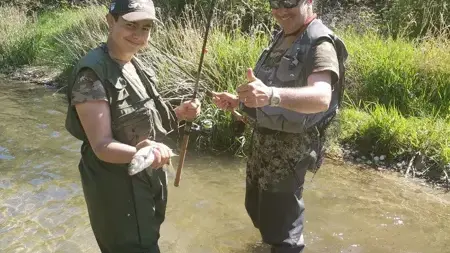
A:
[[312, 41, 339, 83]]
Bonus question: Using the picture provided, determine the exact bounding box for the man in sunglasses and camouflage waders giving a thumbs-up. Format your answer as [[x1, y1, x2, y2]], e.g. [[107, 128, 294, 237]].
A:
[[213, 0, 347, 253]]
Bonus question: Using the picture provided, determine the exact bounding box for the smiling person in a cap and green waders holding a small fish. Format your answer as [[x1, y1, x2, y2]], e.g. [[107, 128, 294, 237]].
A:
[[66, 0, 200, 253]]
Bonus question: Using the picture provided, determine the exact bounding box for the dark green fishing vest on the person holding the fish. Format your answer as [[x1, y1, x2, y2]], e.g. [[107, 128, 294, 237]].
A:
[[65, 44, 177, 146]]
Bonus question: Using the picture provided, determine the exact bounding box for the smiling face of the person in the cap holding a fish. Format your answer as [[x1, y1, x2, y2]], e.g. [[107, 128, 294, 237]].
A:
[[109, 17, 153, 54]]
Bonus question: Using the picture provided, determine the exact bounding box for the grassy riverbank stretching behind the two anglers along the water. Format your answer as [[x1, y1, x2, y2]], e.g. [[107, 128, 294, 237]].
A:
[[0, 4, 450, 188]]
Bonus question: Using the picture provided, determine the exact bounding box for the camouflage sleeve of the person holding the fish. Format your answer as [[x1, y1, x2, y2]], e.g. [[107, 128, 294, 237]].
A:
[[71, 69, 108, 105]]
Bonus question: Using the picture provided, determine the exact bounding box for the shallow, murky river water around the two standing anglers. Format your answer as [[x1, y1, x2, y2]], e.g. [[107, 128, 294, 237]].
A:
[[0, 80, 450, 253]]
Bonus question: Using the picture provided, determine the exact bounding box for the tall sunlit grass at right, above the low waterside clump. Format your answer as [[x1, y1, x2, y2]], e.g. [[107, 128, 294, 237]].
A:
[[343, 31, 450, 117]]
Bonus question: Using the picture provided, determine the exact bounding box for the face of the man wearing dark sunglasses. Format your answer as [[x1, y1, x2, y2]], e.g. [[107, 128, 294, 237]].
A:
[[271, 0, 308, 34]]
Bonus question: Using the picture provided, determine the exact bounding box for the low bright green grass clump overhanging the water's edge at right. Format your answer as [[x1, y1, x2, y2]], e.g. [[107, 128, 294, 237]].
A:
[[338, 104, 450, 179]]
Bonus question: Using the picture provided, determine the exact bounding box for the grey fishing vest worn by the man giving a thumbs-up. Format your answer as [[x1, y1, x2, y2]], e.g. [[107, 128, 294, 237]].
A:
[[250, 19, 348, 133]]
